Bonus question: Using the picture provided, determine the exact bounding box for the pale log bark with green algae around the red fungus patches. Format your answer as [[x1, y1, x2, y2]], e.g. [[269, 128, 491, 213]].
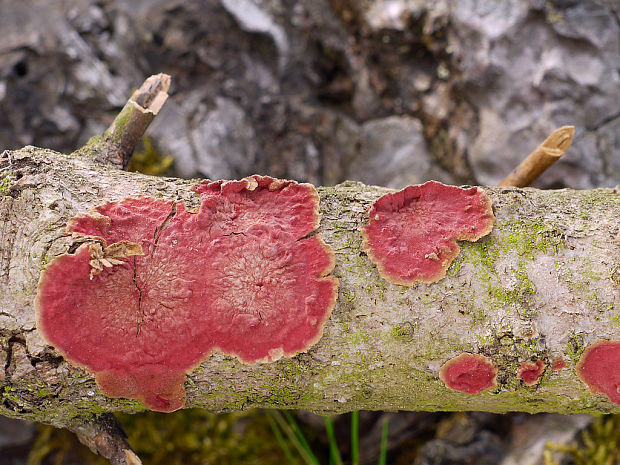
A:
[[0, 147, 620, 425]]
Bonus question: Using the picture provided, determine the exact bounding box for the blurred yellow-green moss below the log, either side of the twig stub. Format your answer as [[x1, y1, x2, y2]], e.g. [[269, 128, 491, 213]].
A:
[[28, 409, 286, 465]]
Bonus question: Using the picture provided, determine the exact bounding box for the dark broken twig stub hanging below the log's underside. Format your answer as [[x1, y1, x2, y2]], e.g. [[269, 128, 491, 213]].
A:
[[68, 413, 142, 465]]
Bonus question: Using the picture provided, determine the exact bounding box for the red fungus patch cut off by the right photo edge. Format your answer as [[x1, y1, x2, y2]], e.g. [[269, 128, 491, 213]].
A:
[[577, 340, 620, 405]]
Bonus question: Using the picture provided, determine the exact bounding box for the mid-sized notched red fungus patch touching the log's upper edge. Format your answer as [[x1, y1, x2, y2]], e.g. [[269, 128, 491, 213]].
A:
[[362, 181, 494, 286]]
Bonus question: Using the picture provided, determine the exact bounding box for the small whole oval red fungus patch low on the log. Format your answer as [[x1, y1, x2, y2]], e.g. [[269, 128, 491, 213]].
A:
[[439, 354, 497, 394]]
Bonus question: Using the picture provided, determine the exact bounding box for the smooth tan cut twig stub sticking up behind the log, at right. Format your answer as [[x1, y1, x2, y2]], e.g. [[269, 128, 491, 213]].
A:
[[498, 126, 575, 187]]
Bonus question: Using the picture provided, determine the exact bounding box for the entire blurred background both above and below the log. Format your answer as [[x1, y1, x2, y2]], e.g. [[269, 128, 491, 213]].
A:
[[0, 0, 620, 465]]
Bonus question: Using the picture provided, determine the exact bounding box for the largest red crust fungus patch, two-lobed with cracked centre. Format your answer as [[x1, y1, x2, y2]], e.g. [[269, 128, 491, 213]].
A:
[[35, 176, 338, 412]]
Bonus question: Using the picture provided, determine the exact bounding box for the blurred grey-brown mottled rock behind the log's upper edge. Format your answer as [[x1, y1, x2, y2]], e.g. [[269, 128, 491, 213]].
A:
[[0, 0, 620, 188]]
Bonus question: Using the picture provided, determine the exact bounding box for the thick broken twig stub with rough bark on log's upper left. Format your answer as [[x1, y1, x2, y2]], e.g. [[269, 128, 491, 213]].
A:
[[77, 73, 170, 169]]
